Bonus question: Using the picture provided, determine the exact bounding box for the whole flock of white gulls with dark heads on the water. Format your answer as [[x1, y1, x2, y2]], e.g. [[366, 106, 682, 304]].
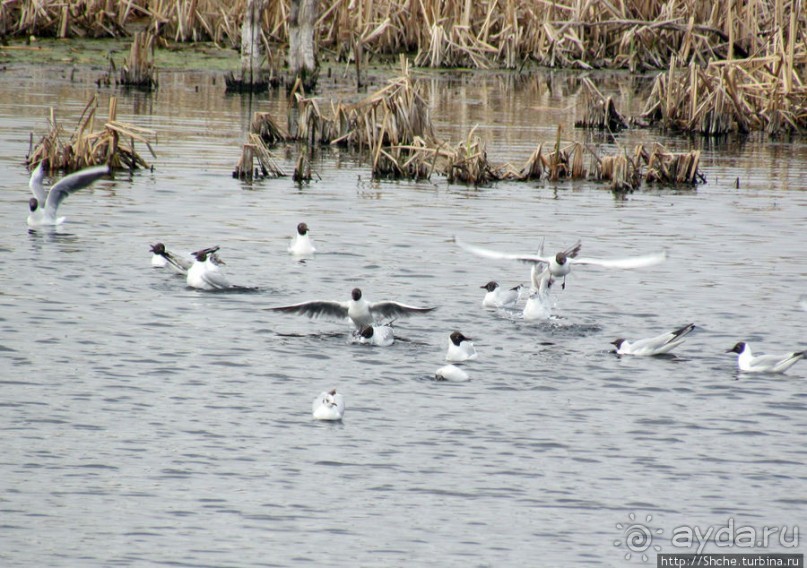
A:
[[28, 160, 807, 421]]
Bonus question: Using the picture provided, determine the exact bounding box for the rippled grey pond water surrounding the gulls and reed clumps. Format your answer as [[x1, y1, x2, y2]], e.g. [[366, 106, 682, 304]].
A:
[[0, 65, 807, 566]]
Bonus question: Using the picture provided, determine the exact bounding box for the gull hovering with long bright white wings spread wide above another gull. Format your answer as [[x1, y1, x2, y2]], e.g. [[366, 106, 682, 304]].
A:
[[454, 237, 667, 288]]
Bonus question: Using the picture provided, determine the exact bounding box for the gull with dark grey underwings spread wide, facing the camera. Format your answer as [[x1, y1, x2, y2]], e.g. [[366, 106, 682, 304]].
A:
[[266, 288, 434, 330]]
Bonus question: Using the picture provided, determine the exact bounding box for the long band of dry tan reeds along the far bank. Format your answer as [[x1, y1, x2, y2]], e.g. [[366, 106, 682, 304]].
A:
[[0, 0, 807, 73]]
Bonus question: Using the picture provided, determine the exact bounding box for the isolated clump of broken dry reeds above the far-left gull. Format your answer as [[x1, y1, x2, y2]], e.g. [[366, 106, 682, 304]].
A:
[[28, 96, 156, 172]]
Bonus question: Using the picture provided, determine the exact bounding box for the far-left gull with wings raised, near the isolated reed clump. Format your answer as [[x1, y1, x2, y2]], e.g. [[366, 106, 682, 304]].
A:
[[28, 160, 110, 227]]
